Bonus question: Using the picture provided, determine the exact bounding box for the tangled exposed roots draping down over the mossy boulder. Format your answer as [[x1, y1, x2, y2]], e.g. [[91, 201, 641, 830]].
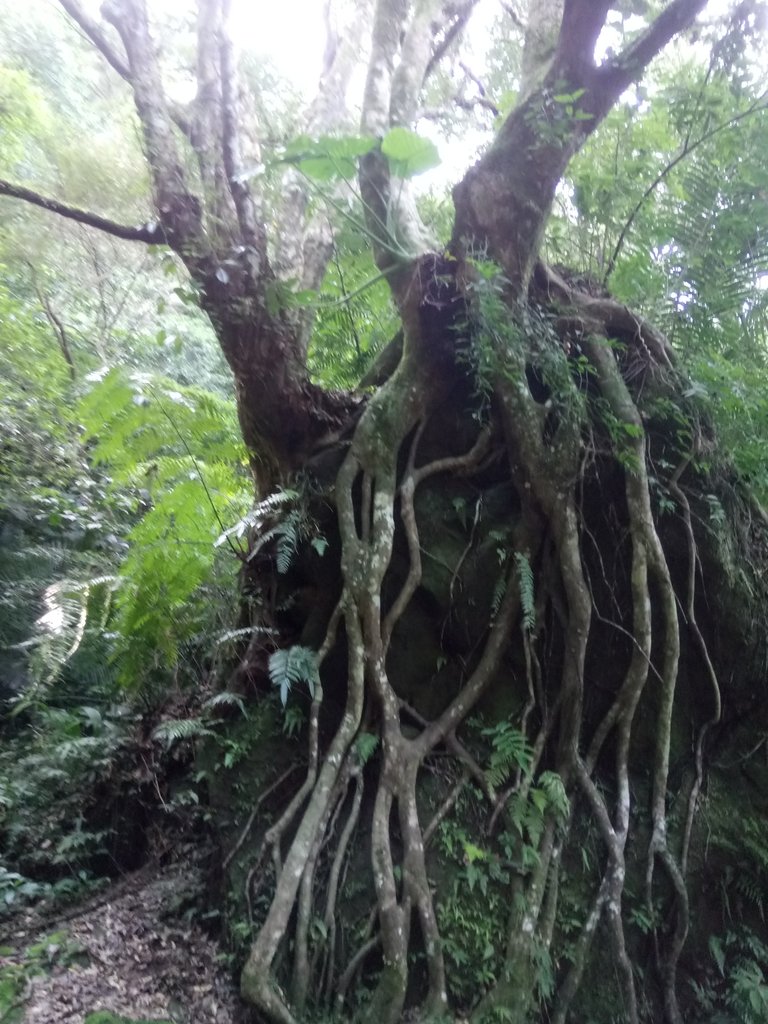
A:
[[237, 276, 720, 1024]]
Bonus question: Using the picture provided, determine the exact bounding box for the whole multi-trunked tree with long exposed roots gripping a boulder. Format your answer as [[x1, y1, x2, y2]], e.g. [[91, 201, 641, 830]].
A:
[[0, 0, 768, 1024]]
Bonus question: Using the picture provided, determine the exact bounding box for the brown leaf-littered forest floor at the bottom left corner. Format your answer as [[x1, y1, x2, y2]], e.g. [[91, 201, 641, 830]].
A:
[[0, 864, 242, 1024]]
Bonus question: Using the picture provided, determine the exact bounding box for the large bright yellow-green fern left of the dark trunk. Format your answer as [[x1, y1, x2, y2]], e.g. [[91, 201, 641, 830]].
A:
[[79, 370, 251, 687]]
